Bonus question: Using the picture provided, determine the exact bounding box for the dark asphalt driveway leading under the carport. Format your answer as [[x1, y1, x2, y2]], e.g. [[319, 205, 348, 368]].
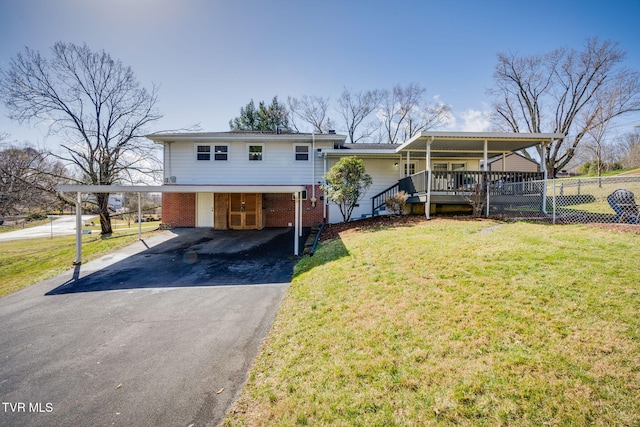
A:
[[0, 229, 295, 426]]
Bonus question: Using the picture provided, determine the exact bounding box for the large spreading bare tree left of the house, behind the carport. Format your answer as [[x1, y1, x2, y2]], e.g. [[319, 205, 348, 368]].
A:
[[0, 42, 162, 234]]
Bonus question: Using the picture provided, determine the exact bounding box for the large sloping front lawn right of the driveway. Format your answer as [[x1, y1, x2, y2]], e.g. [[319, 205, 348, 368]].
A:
[[223, 220, 640, 426]]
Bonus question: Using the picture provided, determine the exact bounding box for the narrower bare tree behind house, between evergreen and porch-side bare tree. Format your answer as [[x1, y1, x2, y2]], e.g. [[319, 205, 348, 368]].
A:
[[338, 89, 382, 143]]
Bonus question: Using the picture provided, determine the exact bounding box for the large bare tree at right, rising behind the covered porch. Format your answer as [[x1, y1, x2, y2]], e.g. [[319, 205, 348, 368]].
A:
[[490, 38, 640, 176]]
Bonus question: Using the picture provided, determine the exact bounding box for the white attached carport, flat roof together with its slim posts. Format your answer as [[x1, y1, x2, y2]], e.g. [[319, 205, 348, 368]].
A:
[[58, 185, 305, 265]]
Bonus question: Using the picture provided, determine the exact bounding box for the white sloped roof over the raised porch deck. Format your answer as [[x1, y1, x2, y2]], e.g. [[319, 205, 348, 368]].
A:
[[396, 131, 564, 158]]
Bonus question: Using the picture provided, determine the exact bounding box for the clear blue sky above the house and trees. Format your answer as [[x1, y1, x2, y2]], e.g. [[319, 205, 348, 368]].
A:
[[0, 0, 640, 145]]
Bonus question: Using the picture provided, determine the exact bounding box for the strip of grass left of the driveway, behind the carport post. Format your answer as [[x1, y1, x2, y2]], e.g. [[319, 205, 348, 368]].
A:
[[0, 231, 159, 297]]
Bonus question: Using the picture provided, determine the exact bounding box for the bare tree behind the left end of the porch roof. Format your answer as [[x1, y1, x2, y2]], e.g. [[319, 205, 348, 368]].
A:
[[378, 83, 451, 144]]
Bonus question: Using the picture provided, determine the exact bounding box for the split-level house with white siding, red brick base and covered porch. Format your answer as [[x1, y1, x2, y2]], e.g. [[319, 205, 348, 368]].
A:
[[147, 131, 563, 229]]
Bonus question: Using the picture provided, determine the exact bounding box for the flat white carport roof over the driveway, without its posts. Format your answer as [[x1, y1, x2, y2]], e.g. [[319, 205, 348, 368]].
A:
[[58, 184, 305, 193]]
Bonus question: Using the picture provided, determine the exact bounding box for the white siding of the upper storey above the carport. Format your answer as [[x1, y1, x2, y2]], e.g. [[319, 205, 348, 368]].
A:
[[165, 141, 333, 185]]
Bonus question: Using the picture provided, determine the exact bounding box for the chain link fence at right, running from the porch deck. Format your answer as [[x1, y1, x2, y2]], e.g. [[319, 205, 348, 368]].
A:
[[487, 175, 640, 224]]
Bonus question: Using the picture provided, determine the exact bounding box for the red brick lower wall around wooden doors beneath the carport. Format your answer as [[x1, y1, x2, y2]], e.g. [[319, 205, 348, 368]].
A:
[[162, 185, 323, 227]]
